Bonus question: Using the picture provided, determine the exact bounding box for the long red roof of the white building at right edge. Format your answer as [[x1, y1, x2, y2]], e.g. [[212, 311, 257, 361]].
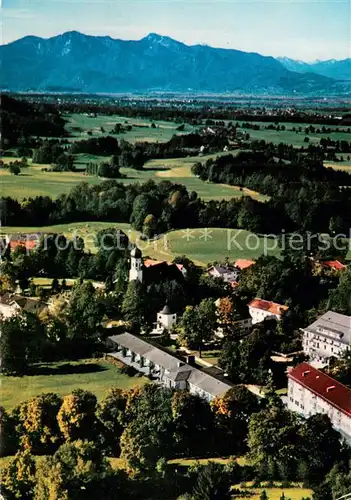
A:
[[288, 363, 351, 417]]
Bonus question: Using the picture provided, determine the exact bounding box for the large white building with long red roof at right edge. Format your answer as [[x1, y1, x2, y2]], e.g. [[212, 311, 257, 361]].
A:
[[288, 363, 351, 444]]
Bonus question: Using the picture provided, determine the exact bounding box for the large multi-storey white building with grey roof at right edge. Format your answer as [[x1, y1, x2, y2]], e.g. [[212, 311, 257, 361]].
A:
[[301, 311, 351, 362]]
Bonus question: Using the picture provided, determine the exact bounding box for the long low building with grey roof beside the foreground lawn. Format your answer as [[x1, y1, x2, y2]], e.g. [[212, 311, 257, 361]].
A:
[[108, 333, 231, 401]]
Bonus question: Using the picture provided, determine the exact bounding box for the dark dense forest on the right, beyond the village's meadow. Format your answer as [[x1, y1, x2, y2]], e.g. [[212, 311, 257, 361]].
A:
[[192, 152, 351, 234]]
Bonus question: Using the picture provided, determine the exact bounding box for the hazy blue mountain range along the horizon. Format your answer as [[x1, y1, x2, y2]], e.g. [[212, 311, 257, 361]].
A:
[[0, 31, 351, 96]]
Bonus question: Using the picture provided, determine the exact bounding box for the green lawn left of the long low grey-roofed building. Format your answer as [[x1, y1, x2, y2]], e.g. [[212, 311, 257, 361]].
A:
[[0, 359, 147, 410]]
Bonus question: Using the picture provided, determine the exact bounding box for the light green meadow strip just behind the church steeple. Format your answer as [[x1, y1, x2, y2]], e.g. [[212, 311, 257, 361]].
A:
[[2, 222, 280, 266]]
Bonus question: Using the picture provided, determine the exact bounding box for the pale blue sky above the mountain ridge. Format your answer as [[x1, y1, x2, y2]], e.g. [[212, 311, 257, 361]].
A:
[[0, 0, 351, 61]]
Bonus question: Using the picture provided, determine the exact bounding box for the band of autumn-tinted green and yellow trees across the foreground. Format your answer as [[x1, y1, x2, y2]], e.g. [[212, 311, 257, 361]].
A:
[[0, 384, 350, 500]]
